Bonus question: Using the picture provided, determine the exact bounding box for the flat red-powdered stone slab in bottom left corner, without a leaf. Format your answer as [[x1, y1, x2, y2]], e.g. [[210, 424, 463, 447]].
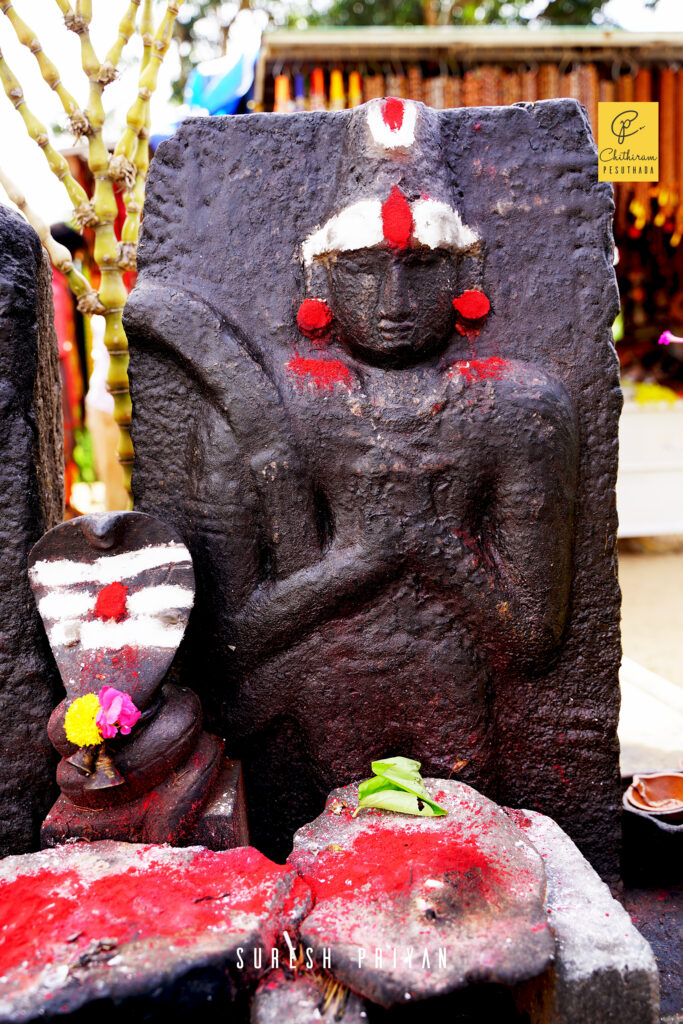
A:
[[0, 841, 310, 1024]]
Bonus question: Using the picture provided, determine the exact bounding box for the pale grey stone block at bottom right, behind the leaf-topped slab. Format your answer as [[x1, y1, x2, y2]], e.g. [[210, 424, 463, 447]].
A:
[[508, 811, 659, 1024]]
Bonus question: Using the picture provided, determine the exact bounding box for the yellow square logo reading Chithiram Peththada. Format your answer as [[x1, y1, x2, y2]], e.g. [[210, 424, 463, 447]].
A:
[[598, 103, 659, 181]]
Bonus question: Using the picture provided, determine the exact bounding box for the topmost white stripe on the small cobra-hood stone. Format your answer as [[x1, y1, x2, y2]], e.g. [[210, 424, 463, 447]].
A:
[[30, 544, 191, 587]]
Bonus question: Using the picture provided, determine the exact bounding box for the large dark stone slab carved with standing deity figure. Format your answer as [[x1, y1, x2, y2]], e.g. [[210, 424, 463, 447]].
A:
[[126, 99, 620, 872]]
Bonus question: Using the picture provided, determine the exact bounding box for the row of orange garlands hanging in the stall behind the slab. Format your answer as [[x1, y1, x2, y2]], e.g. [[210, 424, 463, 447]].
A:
[[265, 59, 683, 247]]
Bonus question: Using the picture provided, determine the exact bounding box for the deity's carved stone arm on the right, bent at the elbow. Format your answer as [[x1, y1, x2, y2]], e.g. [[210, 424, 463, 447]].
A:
[[432, 364, 579, 667]]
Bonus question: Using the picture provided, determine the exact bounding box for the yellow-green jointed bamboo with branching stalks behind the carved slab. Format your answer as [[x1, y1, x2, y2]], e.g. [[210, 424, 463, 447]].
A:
[[0, 0, 183, 505]]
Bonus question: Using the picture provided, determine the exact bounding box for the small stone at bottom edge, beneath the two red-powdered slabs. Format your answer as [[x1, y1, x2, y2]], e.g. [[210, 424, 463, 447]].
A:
[[250, 970, 368, 1024]]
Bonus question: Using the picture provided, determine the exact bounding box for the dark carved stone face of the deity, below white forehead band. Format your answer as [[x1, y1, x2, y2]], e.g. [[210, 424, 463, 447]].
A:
[[328, 247, 456, 366]]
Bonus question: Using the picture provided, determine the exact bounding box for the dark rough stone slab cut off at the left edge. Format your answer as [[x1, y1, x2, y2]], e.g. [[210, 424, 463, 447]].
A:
[[0, 204, 63, 856]]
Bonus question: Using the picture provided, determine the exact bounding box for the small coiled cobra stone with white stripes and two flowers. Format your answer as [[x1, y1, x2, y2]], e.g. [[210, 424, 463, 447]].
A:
[[29, 512, 247, 848]]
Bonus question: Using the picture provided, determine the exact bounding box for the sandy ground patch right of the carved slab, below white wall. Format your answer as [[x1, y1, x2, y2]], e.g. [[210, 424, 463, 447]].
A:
[[618, 540, 683, 687]]
